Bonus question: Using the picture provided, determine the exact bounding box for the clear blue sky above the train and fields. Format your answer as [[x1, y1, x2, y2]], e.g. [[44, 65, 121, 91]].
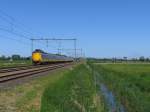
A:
[[0, 0, 150, 58]]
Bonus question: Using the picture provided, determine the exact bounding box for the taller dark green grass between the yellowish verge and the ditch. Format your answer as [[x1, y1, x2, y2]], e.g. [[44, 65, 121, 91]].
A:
[[41, 65, 104, 112]]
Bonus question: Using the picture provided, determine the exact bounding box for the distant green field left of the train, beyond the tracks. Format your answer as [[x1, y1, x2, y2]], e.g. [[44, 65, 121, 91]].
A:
[[0, 60, 32, 68]]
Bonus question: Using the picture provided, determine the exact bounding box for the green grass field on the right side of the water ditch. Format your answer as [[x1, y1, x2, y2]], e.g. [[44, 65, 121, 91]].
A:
[[95, 64, 150, 112]]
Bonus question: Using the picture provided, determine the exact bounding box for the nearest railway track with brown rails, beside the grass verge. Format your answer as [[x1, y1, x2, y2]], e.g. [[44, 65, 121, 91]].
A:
[[0, 63, 72, 83]]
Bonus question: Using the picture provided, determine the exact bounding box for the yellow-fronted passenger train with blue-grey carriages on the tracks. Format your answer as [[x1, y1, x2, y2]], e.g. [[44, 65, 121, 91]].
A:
[[32, 49, 74, 65]]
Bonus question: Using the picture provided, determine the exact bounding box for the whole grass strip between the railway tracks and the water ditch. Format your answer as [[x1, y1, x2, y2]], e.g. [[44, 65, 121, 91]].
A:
[[0, 65, 104, 112]]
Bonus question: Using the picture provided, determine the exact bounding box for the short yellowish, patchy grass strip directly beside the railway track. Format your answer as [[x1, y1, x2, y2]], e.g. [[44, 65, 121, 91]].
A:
[[0, 65, 71, 112]]
